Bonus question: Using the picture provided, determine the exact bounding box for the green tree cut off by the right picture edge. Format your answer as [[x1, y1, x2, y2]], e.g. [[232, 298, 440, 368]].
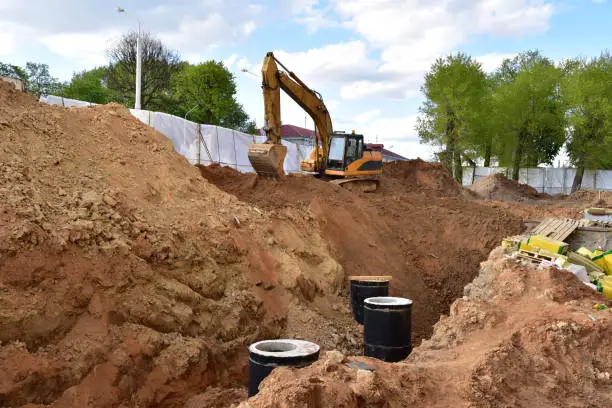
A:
[[563, 52, 612, 192]]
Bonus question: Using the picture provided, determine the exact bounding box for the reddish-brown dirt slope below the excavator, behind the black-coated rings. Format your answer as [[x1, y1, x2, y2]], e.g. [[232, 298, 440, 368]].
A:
[[200, 160, 523, 344]]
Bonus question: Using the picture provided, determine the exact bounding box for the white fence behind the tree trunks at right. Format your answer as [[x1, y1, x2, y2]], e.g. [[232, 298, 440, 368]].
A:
[[463, 167, 612, 194]]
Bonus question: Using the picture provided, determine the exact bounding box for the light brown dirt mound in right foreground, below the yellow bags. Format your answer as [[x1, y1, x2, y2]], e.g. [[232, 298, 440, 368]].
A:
[[246, 250, 612, 408]]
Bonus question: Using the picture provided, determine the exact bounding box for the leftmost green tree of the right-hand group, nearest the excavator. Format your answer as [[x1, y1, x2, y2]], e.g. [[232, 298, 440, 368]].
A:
[[417, 53, 490, 181]]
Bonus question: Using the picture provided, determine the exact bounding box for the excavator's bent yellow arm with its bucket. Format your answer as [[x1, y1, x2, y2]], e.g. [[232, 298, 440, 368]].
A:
[[248, 52, 333, 177]]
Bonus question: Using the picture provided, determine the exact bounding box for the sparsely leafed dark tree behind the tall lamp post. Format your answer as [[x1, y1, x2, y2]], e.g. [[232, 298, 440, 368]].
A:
[[106, 31, 183, 112]]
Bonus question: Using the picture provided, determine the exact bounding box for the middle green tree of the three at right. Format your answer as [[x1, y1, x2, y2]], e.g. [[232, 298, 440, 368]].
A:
[[492, 51, 565, 180]]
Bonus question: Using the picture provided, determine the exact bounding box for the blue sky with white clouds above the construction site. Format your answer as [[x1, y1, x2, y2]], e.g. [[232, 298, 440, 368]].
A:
[[0, 0, 612, 159]]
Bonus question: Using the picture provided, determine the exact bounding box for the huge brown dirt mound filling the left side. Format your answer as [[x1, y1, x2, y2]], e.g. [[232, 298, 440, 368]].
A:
[[0, 83, 359, 407]]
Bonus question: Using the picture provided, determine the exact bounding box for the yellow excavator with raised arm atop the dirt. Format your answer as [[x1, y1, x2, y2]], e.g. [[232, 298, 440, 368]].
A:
[[248, 52, 382, 191]]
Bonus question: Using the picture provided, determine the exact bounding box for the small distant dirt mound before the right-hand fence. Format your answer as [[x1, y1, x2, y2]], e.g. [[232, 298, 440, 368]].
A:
[[469, 173, 550, 202]]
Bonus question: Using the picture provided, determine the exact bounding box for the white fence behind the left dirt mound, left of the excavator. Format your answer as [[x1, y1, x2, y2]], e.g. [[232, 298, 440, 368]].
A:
[[40, 95, 312, 173]]
